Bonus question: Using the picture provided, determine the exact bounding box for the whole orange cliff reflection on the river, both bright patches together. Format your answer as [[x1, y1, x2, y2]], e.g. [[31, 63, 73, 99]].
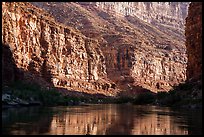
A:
[[50, 105, 191, 135]]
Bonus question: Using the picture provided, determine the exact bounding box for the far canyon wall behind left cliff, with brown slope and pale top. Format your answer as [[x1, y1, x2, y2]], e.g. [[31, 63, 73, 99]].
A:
[[32, 2, 188, 92]]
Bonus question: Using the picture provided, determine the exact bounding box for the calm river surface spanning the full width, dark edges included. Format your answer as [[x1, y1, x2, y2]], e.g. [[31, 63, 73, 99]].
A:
[[2, 104, 202, 135]]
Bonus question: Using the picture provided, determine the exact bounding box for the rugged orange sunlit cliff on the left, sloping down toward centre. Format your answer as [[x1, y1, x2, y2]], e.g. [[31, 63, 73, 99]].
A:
[[2, 2, 117, 95]]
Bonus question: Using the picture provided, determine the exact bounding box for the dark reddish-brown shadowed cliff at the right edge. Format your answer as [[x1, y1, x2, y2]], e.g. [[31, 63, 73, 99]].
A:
[[185, 2, 202, 80]]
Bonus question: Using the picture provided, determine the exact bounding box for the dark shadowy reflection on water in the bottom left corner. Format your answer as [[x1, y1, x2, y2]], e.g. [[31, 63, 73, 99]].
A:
[[2, 107, 52, 135]]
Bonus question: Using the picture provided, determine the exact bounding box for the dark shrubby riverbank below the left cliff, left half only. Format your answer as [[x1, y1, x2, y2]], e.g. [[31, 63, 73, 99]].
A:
[[2, 81, 116, 108]]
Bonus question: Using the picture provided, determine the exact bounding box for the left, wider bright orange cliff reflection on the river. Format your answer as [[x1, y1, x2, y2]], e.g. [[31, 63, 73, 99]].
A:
[[50, 105, 119, 135]]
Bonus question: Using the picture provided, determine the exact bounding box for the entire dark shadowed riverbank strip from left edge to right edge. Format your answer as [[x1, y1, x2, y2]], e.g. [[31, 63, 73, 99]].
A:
[[2, 78, 202, 109]]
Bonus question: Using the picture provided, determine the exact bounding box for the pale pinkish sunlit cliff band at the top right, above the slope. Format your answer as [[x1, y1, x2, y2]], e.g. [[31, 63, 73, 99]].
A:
[[96, 2, 188, 29]]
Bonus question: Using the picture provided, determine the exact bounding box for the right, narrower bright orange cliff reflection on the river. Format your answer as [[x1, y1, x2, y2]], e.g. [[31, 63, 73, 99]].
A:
[[131, 107, 188, 135]]
